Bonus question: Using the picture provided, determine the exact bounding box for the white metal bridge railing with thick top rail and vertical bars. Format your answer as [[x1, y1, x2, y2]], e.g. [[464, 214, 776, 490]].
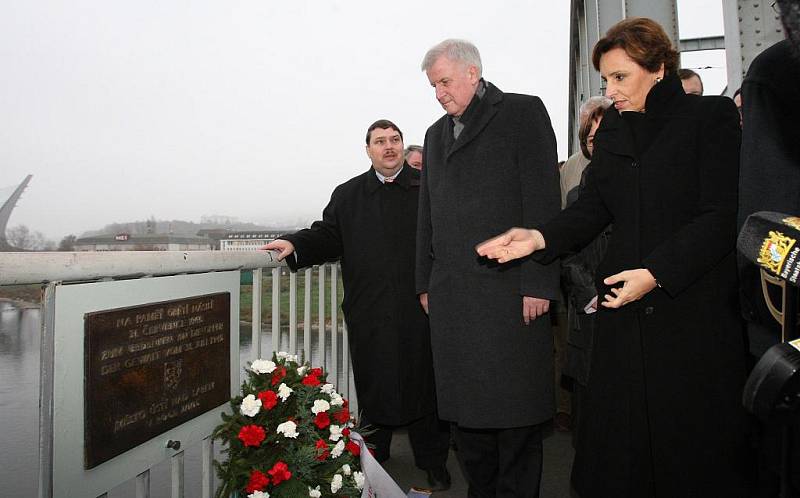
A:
[[0, 251, 358, 498]]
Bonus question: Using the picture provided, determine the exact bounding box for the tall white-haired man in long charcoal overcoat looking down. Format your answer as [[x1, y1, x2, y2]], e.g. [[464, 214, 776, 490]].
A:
[[417, 40, 561, 497]]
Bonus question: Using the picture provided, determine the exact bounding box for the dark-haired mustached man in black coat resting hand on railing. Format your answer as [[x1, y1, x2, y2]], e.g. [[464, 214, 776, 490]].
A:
[[264, 120, 450, 489]]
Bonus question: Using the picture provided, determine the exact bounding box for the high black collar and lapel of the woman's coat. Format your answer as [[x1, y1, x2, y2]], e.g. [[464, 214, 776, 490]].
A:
[[595, 74, 686, 157]]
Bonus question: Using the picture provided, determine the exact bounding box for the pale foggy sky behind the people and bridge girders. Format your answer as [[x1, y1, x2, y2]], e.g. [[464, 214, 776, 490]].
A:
[[0, 0, 725, 240]]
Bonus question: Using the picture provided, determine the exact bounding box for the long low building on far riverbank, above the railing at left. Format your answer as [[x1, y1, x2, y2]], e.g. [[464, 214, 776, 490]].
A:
[[75, 233, 213, 251]]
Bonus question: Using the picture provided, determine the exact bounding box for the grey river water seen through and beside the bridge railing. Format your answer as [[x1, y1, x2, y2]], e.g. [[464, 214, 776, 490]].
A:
[[0, 301, 353, 498]]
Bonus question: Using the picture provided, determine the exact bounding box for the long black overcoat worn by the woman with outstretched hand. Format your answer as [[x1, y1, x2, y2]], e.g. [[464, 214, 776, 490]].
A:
[[537, 76, 747, 498]]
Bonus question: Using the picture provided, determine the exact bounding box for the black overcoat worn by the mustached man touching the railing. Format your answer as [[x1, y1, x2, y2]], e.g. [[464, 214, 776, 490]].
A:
[[281, 164, 436, 425]]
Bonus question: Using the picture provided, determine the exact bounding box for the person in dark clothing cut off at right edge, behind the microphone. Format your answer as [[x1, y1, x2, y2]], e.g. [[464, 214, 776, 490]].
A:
[[738, 0, 800, 497]]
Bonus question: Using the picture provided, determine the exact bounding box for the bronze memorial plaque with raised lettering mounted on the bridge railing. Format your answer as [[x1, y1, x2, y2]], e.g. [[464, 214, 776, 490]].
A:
[[84, 292, 231, 469]]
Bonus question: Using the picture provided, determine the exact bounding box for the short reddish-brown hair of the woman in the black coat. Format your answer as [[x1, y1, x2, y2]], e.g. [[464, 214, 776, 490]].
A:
[[592, 17, 678, 74]]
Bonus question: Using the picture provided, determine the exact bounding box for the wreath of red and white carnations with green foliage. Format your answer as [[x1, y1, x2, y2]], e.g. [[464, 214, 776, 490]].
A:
[[213, 352, 365, 498]]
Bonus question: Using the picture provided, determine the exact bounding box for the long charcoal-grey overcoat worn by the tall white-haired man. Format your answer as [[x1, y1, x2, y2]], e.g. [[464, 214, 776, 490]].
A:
[[417, 84, 561, 428]]
